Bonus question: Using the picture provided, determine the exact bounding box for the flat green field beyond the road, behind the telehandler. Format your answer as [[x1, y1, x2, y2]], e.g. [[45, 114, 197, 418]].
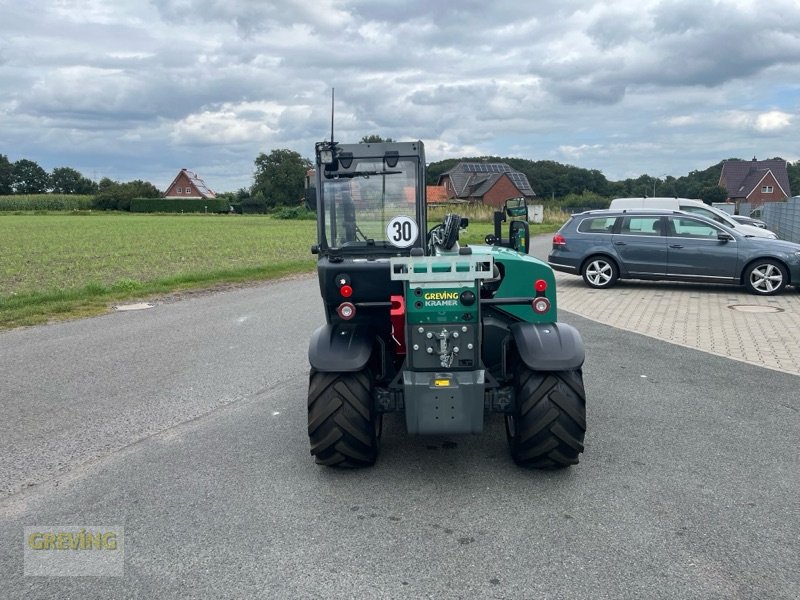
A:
[[0, 209, 558, 329]]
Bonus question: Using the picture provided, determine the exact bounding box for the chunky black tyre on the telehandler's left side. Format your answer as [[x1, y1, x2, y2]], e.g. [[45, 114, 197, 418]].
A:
[[308, 369, 381, 468]]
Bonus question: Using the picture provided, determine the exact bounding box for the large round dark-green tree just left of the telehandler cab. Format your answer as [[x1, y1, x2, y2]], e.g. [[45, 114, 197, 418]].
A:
[[251, 149, 311, 208]]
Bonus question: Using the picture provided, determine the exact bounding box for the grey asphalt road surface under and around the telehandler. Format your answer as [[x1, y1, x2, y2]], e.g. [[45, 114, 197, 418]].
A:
[[0, 279, 800, 599]]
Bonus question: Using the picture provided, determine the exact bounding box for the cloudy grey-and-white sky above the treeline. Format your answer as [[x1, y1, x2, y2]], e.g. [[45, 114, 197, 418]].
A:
[[0, 0, 800, 191]]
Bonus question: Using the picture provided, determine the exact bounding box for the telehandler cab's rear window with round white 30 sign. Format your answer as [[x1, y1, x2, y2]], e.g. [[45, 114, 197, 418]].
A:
[[321, 158, 419, 249]]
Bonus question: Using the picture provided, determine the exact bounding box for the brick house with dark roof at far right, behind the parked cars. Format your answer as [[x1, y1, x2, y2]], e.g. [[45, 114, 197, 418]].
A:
[[719, 157, 792, 208]]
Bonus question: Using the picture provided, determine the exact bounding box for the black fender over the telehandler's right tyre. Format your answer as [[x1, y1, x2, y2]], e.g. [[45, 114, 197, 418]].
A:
[[509, 323, 586, 371]]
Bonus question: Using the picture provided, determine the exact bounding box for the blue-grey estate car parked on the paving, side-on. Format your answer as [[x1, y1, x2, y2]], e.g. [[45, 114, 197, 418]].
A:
[[548, 209, 800, 296]]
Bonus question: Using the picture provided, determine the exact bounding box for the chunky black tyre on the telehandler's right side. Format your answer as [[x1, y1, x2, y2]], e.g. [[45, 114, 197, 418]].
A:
[[506, 365, 586, 469]]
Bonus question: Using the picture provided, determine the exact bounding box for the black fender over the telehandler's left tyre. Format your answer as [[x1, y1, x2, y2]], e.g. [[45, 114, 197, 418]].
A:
[[308, 323, 375, 373]]
